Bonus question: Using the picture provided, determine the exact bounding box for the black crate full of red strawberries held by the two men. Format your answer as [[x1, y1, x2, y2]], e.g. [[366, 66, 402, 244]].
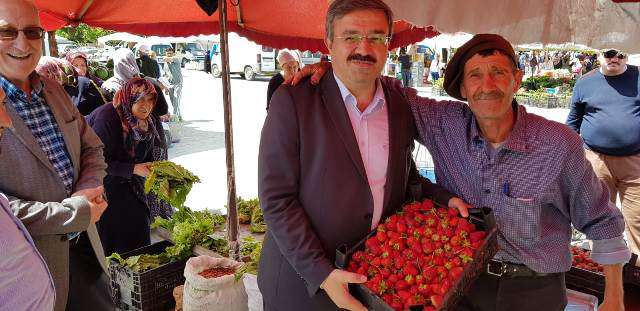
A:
[[336, 199, 498, 311]]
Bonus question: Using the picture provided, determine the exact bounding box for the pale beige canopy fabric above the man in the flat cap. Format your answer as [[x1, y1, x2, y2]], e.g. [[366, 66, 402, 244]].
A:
[[385, 0, 640, 53]]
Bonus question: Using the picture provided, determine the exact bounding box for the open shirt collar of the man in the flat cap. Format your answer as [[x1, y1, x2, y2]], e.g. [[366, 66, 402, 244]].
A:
[[470, 99, 529, 152]]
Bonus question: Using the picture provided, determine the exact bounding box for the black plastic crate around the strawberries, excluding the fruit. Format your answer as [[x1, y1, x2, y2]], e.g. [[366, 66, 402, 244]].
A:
[[335, 207, 498, 311]]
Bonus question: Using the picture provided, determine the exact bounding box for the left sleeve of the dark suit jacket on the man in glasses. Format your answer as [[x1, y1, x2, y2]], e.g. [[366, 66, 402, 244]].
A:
[[258, 88, 334, 296]]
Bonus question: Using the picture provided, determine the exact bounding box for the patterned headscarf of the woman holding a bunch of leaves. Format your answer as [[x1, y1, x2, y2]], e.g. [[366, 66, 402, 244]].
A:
[[113, 77, 160, 158]]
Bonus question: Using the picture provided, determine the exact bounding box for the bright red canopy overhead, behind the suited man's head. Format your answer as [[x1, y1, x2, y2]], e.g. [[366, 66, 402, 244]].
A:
[[35, 0, 438, 52]]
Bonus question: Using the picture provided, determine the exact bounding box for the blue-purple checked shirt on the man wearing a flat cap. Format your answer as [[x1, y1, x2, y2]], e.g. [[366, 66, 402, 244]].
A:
[[405, 88, 631, 273]]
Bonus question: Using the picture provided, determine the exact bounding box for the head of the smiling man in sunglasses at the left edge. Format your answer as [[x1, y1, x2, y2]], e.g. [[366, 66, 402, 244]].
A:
[[0, 0, 42, 90]]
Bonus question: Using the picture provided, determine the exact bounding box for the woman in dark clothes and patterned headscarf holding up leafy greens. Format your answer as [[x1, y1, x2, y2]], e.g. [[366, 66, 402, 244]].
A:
[[87, 78, 166, 254]]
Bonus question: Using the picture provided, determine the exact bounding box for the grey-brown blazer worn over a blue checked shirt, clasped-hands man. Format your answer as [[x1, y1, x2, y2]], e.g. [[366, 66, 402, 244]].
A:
[[0, 78, 107, 310]]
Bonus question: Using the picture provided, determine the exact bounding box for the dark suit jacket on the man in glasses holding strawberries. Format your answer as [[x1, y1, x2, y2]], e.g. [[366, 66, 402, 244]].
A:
[[258, 71, 452, 311]]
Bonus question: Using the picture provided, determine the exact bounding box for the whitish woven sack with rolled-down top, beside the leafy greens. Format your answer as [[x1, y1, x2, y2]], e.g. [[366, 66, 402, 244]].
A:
[[183, 256, 247, 311]]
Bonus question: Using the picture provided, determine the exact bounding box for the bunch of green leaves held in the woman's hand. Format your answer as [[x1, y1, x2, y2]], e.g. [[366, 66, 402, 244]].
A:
[[144, 161, 200, 208]]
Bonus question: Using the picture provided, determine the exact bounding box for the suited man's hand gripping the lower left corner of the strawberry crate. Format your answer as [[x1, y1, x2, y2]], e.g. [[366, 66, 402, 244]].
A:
[[320, 269, 367, 311]]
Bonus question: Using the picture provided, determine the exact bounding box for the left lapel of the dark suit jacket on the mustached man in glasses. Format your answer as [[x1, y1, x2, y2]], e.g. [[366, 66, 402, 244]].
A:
[[320, 70, 368, 181]]
